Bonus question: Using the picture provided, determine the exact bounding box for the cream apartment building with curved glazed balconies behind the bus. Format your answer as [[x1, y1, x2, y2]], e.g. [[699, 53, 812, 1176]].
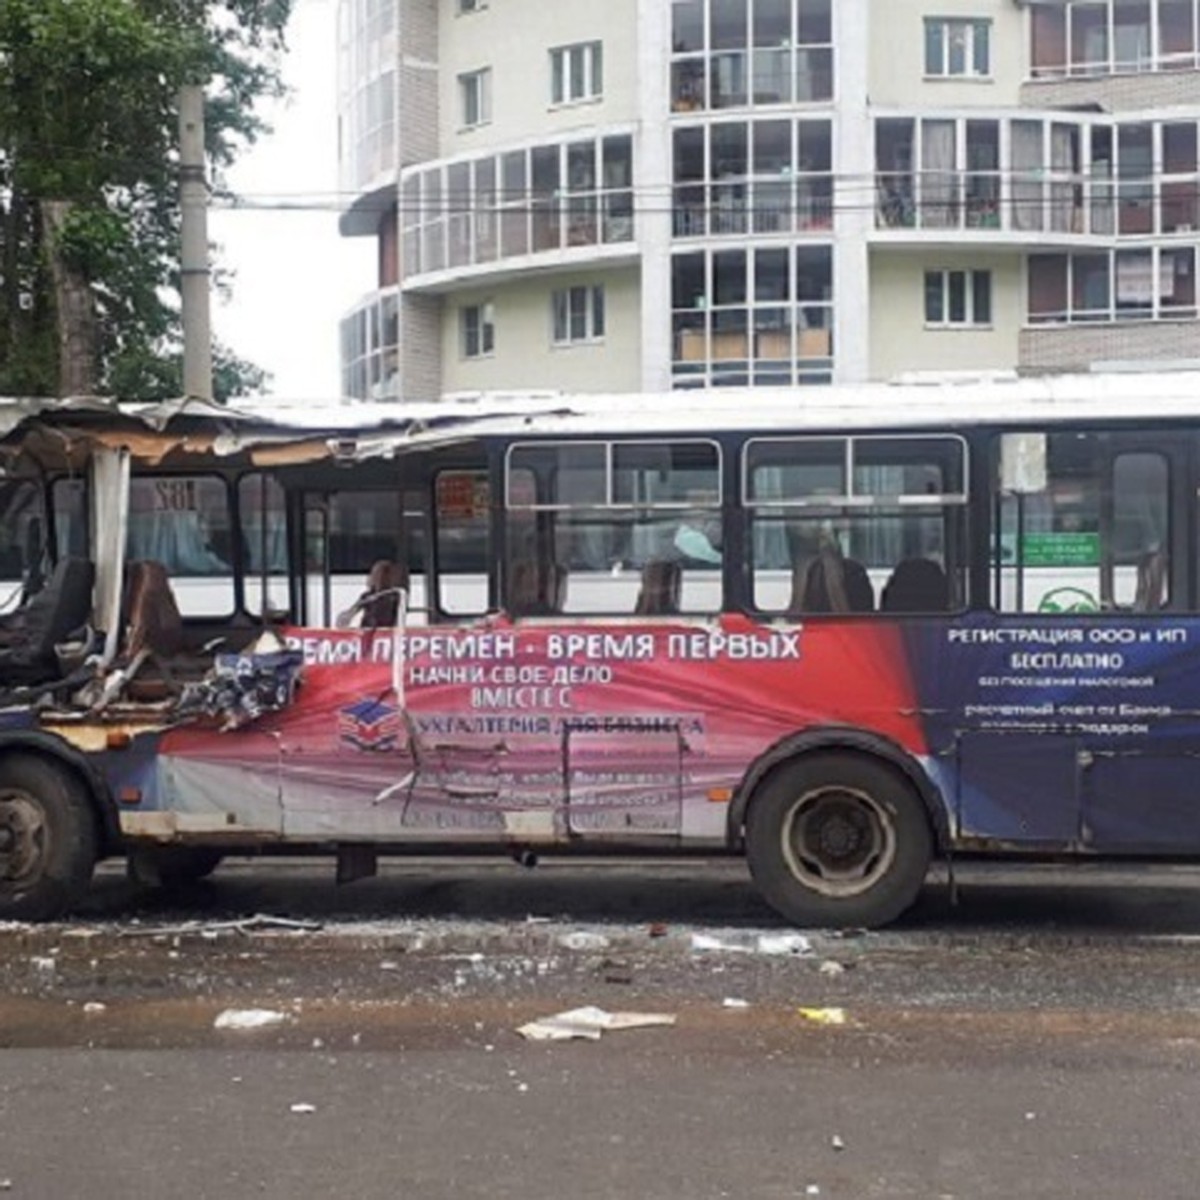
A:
[[338, 0, 1200, 398]]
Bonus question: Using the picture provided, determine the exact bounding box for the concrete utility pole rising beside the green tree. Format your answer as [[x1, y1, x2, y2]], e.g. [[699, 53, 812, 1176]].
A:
[[179, 84, 212, 400]]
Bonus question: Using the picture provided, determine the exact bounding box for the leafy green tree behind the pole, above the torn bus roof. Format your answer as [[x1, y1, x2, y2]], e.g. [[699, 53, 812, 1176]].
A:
[[0, 0, 293, 400]]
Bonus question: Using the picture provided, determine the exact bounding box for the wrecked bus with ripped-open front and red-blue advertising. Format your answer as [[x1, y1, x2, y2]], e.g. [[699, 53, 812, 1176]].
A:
[[0, 373, 1200, 926]]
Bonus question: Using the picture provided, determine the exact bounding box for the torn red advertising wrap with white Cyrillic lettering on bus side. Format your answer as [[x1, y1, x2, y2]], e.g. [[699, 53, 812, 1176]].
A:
[[160, 617, 925, 841]]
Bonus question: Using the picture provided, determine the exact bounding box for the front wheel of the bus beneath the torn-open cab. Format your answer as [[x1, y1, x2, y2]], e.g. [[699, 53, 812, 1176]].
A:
[[0, 755, 98, 920]]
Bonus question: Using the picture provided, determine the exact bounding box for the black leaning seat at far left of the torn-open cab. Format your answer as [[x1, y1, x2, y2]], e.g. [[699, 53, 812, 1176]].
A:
[[0, 558, 96, 683]]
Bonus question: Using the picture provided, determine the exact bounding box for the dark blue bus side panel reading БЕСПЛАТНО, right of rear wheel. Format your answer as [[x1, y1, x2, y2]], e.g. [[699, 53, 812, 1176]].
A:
[[905, 616, 1200, 853]]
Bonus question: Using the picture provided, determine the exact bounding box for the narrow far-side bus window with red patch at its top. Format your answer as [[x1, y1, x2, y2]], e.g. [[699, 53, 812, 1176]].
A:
[[433, 469, 492, 617]]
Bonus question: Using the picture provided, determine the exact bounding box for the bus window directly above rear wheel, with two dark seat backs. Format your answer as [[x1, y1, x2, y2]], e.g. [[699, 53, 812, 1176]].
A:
[[744, 437, 967, 617]]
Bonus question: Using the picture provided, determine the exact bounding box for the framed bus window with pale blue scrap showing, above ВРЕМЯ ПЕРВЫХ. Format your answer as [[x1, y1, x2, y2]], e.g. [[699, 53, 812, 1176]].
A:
[[505, 442, 722, 617]]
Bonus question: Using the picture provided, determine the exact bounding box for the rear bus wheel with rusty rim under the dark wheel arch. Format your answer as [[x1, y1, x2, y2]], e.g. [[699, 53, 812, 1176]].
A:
[[746, 751, 934, 929]]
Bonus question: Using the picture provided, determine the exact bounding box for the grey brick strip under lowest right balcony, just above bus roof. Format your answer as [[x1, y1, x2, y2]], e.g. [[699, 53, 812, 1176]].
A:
[[1020, 320, 1200, 374]]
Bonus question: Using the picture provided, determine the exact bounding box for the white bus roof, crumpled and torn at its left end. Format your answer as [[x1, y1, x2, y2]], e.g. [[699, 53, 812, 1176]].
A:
[[7, 371, 1200, 462]]
